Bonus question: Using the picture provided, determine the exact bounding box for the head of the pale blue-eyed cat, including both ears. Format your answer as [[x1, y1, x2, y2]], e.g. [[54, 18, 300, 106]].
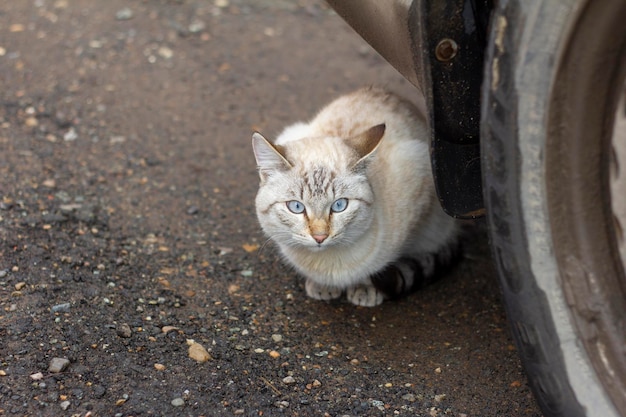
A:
[[252, 124, 385, 250]]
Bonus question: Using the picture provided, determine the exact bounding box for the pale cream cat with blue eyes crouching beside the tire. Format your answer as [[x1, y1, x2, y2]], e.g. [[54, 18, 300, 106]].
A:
[[252, 87, 460, 307]]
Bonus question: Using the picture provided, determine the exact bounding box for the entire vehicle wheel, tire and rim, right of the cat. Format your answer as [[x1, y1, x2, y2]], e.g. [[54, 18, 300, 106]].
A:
[[481, 0, 626, 417]]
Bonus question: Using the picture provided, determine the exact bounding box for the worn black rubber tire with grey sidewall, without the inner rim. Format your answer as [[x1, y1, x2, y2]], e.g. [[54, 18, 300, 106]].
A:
[[481, 0, 620, 417]]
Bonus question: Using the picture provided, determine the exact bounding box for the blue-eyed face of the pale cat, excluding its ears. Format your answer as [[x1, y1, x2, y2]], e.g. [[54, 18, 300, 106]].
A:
[[256, 154, 373, 250]]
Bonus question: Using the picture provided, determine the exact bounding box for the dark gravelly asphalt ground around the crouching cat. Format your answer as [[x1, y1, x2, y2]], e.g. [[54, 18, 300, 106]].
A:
[[0, 0, 540, 417]]
